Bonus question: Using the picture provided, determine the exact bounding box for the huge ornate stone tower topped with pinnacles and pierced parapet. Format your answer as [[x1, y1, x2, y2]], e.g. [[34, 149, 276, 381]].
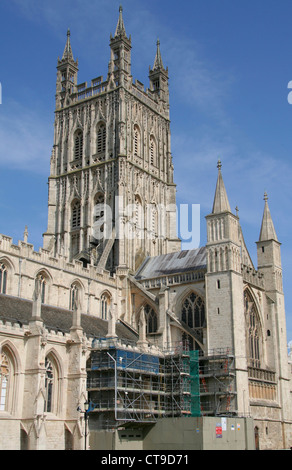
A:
[[44, 7, 180, 271]]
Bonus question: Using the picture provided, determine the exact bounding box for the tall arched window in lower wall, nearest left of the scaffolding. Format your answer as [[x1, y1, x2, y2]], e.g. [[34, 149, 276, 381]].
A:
[[44, 354, 58, 413]]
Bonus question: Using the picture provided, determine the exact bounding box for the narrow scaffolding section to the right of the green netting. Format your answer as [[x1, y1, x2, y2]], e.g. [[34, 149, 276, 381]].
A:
[[199, 348, 237, 416]]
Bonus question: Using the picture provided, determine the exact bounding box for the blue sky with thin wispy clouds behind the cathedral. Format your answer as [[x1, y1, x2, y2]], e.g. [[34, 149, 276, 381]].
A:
[[0, 0, 292, 346]]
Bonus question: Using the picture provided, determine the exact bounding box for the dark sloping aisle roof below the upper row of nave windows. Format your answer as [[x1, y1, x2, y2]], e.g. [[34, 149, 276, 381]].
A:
[[0, 294, 138, 341]]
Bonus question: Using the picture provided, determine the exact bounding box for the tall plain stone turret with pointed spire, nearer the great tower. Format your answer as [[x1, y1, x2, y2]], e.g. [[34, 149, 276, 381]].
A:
[[206, 161, 248, 413]]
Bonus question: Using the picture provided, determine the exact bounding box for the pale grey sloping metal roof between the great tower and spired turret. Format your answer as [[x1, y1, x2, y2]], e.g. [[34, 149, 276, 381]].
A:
[[135, 247, 207, 280]]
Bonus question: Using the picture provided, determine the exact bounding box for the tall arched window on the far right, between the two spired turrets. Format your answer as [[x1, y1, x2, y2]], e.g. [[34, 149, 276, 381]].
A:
[[244, 290, 262, 367]]
